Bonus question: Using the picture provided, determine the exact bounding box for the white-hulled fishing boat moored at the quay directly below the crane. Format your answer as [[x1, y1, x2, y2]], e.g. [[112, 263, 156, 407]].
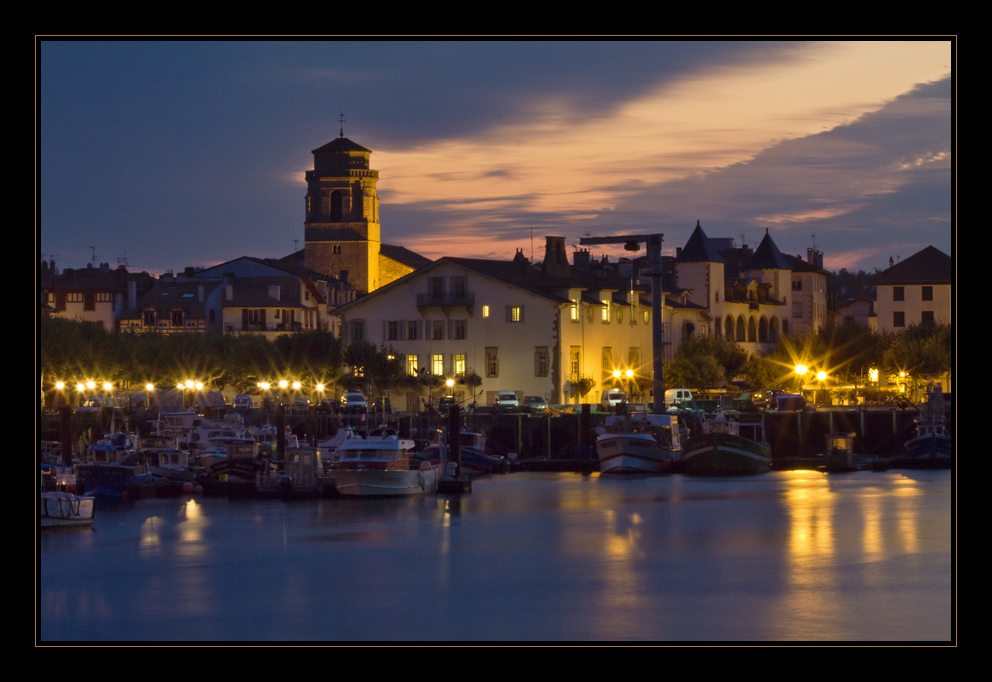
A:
[[596, 413, 682, 474]]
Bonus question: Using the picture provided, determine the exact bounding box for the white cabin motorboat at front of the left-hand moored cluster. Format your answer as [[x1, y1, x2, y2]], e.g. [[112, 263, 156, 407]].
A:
[[333, 428, 439, 497]]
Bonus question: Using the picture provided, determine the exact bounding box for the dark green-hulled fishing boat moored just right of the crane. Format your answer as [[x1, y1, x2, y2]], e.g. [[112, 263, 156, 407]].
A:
[[682, 413, 772, 476]]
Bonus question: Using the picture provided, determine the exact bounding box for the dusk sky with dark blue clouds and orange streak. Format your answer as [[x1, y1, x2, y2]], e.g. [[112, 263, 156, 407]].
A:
[[36, 38, 956, 275]]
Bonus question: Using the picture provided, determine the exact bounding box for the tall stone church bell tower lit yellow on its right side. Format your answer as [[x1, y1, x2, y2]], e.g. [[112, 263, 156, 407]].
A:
[[304, 132, 380, 293]]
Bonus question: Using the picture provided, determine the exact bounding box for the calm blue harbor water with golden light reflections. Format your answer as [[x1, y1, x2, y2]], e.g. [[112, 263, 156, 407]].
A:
[[37, 471, 955, 644]]
